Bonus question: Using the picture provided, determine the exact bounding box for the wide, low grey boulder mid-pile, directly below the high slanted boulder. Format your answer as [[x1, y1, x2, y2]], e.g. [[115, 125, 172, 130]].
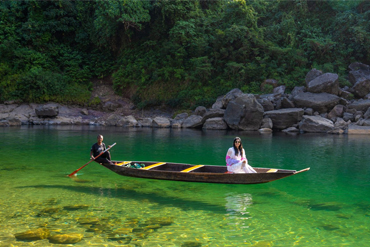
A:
[[293, 92, 340, 113]]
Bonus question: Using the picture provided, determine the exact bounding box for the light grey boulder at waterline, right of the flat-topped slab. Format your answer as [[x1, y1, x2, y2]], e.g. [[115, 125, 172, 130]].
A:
[[299, 115, 334, 133]]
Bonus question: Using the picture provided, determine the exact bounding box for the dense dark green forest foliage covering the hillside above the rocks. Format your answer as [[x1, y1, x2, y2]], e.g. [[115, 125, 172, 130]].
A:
[[0, 0, 370, 108]]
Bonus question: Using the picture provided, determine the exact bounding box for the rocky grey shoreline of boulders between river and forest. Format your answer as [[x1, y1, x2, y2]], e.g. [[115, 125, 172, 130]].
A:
[[0, 63, 370, 134]]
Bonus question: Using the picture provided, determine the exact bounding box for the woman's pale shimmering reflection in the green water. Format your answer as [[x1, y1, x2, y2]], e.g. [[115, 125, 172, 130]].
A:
[[225, 193, 253, 219]]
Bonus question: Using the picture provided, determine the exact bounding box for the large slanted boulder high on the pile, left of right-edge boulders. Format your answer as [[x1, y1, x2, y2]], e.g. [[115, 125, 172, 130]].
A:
[[307, 73, 340, 95]]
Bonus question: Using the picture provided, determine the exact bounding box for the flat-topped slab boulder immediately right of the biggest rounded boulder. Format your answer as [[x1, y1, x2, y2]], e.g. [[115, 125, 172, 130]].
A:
[[264, 108, 304, 130]]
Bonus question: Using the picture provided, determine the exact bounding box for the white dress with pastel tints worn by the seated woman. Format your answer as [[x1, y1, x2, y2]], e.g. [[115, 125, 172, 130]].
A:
[[226, 147, 257, 173]]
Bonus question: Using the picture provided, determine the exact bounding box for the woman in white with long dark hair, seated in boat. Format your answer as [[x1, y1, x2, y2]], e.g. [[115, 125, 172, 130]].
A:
[[226, 137, 256, 173]]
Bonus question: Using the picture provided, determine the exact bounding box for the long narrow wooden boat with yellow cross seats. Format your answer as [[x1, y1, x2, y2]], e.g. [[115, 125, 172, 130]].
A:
[[102, 161, 310, 184]]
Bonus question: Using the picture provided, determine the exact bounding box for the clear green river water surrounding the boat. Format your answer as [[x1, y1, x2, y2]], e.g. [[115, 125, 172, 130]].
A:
[[0, 126, 370, 246]]
